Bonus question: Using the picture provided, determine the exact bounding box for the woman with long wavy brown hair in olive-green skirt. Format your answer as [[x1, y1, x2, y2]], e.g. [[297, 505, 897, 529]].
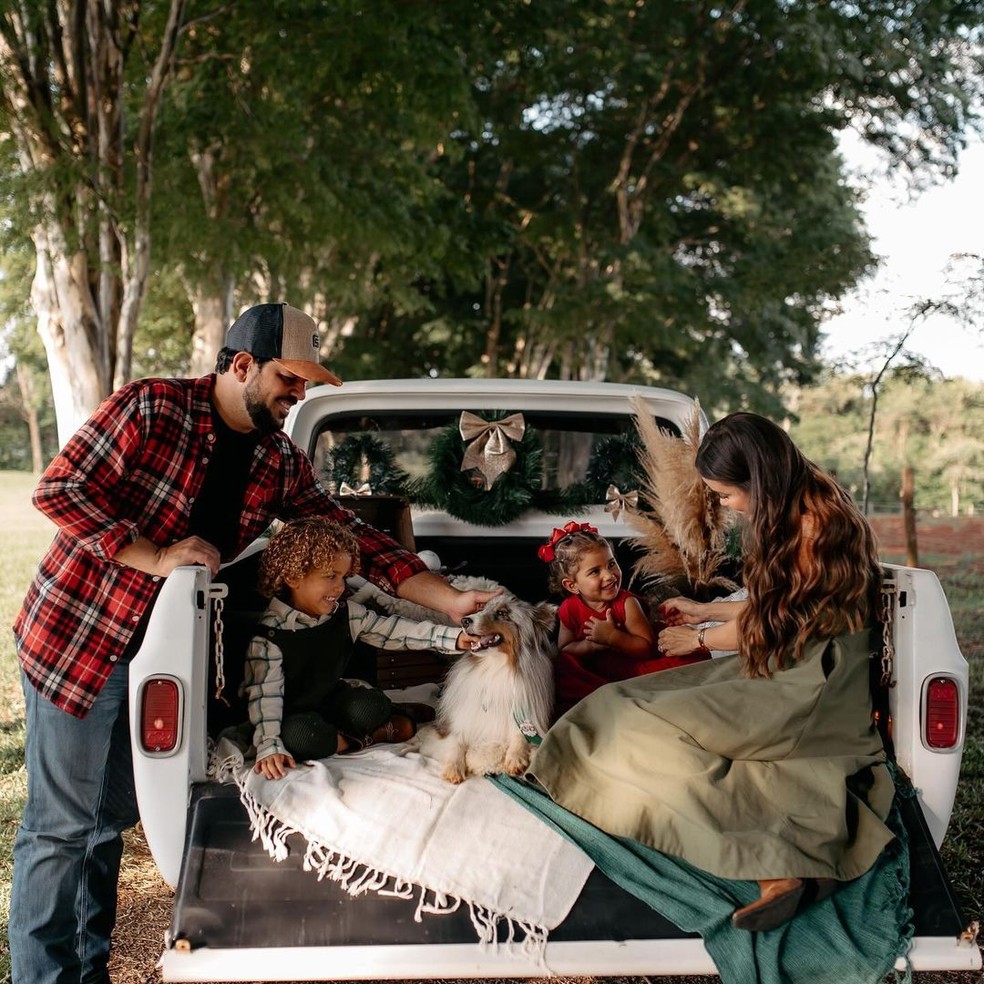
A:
[[531, 413, 894, 930]]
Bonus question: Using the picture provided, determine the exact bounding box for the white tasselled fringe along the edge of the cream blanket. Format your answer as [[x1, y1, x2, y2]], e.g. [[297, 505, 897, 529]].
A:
[[231, 756, 550, 973]]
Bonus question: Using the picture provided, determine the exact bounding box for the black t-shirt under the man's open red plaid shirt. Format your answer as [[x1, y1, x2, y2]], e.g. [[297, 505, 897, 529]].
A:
[[188, 407, 260, 561]]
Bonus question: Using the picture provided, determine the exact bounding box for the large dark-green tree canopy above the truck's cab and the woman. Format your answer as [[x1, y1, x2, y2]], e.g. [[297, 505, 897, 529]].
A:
[[400, 0, 981, 403]]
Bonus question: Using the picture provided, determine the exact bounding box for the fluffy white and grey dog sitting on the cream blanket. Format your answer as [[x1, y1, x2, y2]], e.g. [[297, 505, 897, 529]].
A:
[[421, 591, 557, 783]]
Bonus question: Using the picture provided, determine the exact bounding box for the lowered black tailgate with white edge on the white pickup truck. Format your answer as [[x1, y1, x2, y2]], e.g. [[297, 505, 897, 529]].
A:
[[164, 783, 976, 980]]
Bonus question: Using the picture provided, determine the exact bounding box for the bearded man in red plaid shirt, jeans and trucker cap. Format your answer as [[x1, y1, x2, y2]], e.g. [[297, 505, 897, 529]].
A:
[[9, 304, 491, 984]]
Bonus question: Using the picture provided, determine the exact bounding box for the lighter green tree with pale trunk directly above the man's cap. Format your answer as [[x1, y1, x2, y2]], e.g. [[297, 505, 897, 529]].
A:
[[149, 0, 480, 371]]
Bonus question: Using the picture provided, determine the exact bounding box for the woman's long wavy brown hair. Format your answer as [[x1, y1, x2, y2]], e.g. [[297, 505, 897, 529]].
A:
[[696, 413, 881, 676]]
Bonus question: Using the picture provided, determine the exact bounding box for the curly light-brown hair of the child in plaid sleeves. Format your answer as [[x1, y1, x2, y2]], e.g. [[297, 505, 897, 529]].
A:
[[257, 516, 359, 598]]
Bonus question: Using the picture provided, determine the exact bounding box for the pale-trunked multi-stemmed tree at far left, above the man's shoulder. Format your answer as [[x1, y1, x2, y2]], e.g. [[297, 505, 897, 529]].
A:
[[0, 0, 185, 441]]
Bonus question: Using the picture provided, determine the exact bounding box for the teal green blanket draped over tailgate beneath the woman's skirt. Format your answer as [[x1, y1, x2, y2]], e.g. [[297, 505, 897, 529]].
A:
[[490, 776, 914, 984]]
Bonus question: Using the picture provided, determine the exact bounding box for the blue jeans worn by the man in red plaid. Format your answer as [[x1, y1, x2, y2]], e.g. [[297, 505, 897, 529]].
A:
[[9, 663, 138, 984]]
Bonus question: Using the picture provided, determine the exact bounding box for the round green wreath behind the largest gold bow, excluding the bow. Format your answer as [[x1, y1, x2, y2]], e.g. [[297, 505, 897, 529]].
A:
[[407, 411, 559, 526]]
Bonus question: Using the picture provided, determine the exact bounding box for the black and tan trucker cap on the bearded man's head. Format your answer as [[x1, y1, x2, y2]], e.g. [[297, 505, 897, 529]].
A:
[[225, 303, 342, 386]]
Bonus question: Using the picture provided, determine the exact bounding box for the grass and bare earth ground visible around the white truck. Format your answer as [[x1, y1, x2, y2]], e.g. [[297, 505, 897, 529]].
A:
[[0, 472, 984, 984]]
